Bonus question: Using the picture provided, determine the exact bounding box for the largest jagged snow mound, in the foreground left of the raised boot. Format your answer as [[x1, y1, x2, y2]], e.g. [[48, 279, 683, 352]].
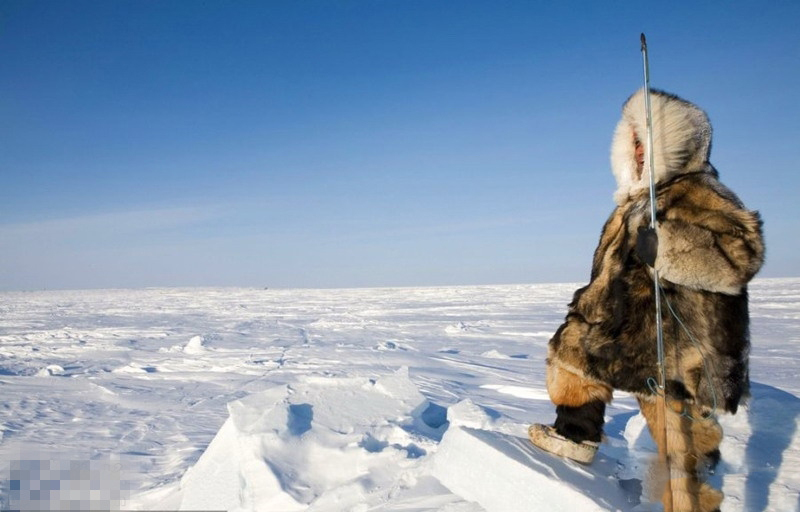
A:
[[181, 369, 437, 511]]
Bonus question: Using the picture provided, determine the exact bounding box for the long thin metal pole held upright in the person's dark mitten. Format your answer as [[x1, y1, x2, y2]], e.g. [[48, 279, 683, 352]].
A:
[[641, 33, 672, 512]]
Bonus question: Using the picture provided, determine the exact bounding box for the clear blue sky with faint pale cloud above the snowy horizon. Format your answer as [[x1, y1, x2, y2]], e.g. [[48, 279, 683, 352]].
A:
[[0, 0, 800, 290]]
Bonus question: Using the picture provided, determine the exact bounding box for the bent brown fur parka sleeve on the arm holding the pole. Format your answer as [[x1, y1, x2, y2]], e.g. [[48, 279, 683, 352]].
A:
[[655, 190, 764, 295]]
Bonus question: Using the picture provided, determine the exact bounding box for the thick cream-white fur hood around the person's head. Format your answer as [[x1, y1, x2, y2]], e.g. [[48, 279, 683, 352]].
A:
[[611, 88, 713, 205]]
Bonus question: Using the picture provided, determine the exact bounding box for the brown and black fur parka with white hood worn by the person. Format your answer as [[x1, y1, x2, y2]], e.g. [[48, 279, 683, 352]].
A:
[[548, 90, 764, 412]]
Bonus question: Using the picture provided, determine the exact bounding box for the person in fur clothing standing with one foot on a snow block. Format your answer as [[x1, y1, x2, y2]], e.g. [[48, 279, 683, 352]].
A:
[[529, 89, 764, 511]]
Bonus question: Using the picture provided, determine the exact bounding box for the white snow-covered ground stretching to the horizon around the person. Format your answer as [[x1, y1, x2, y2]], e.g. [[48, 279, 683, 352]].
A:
[[0, 279, 800, 512]]
